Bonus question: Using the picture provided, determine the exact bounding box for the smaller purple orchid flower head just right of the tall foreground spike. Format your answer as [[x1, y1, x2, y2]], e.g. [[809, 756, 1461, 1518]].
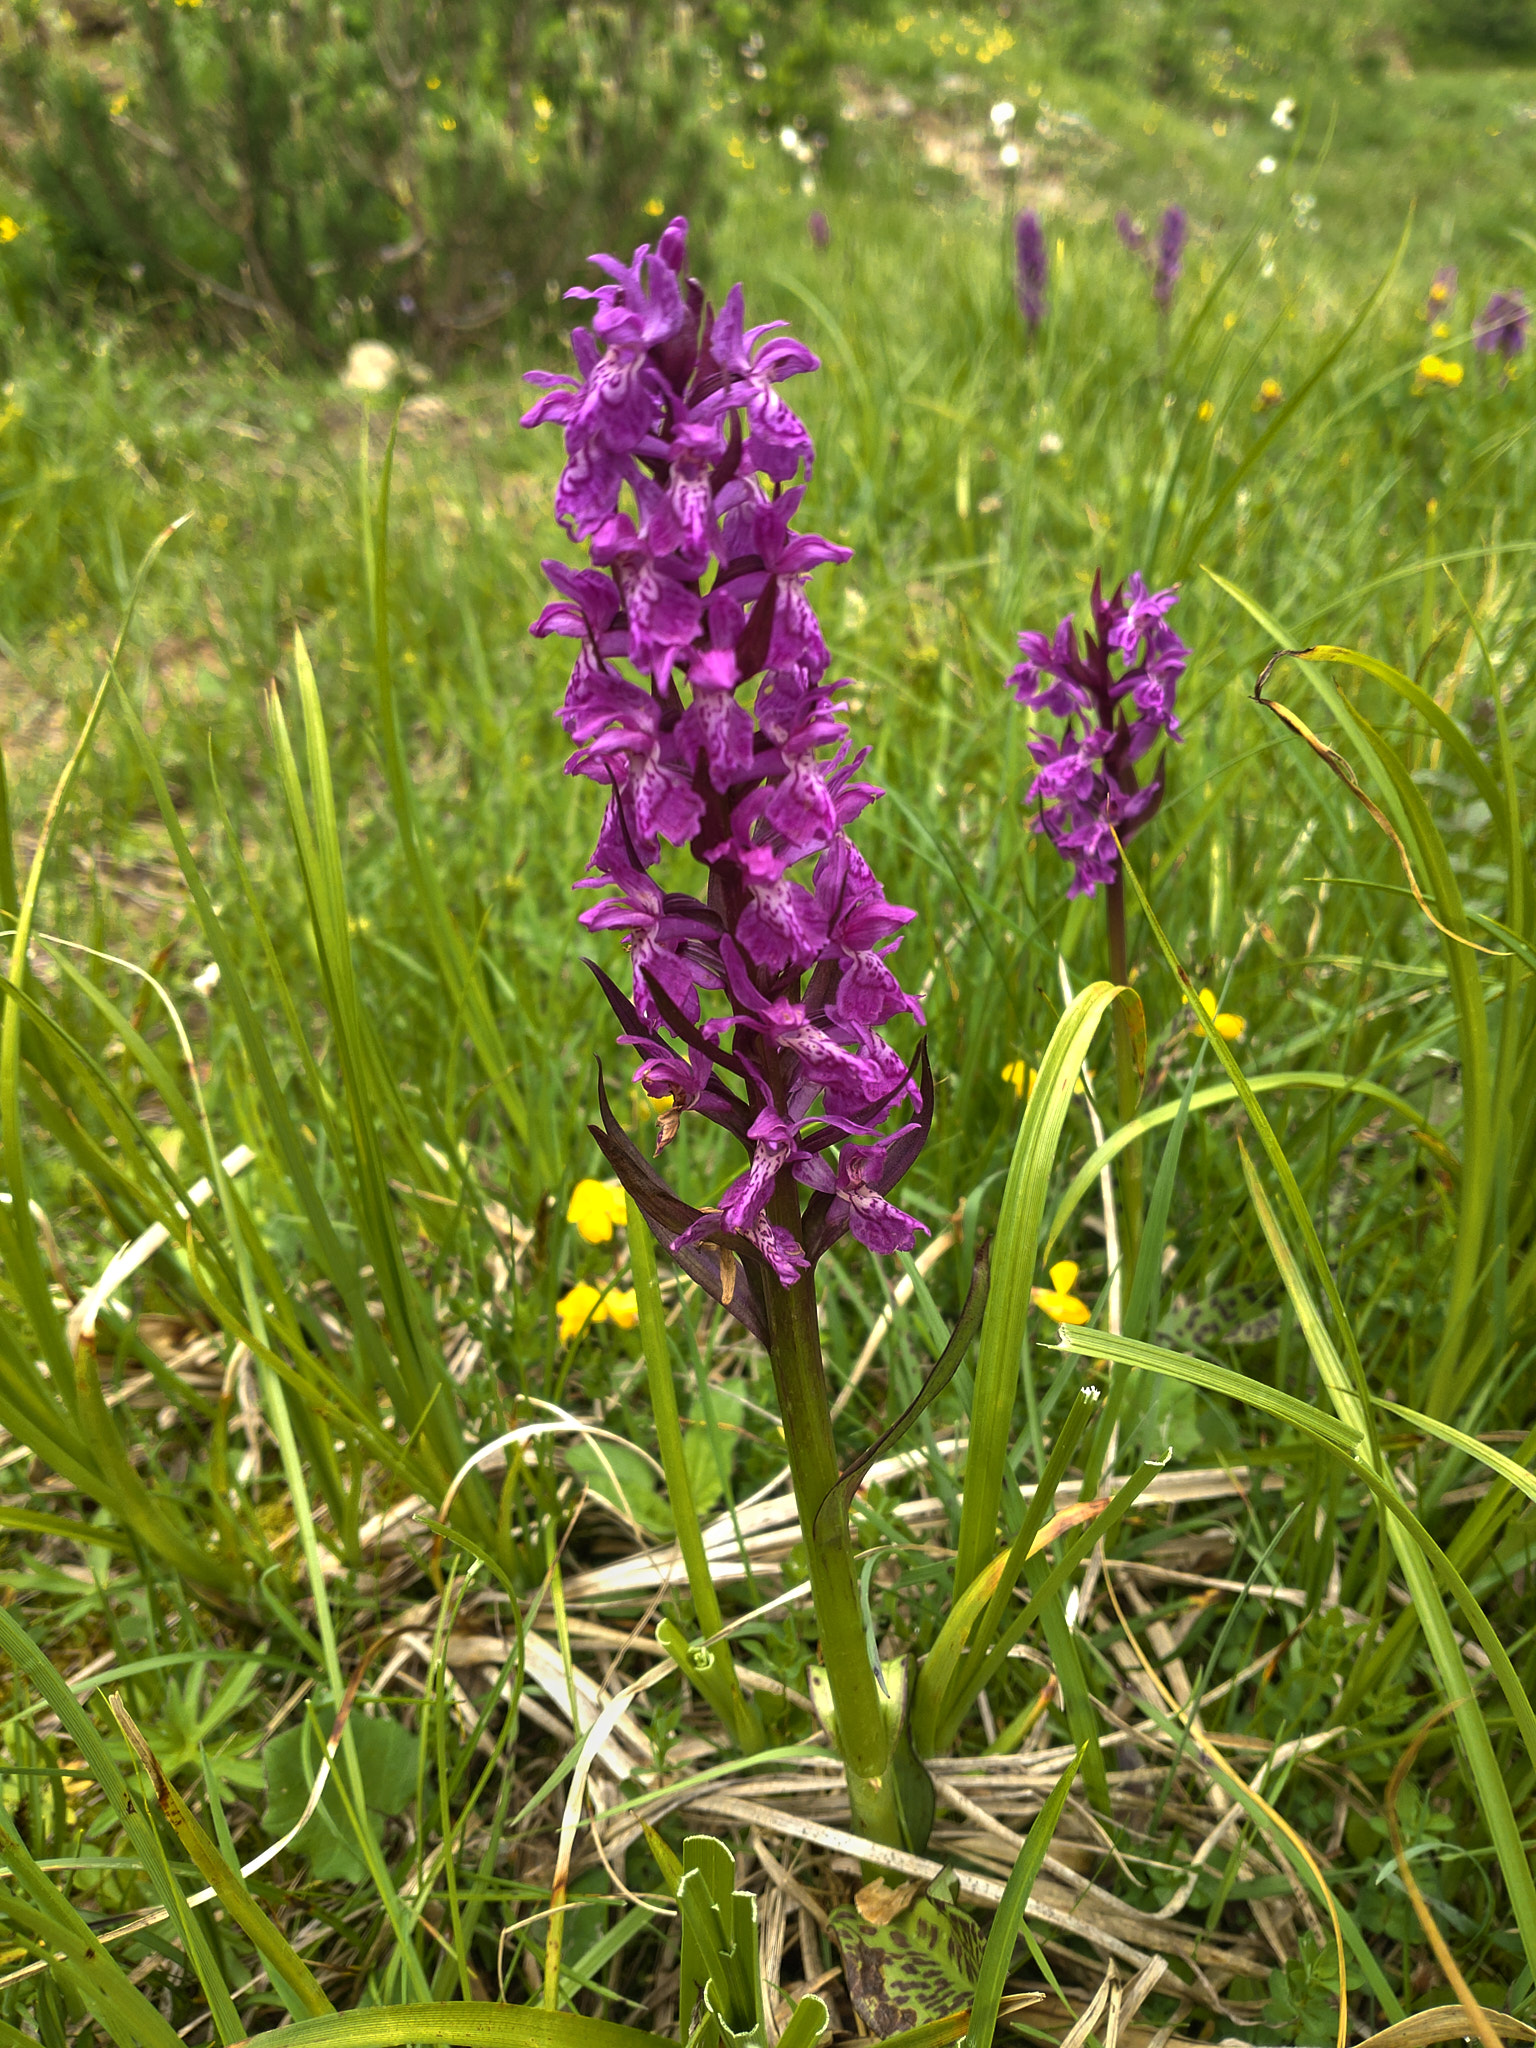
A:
[[1008, 575, 1190, 897]]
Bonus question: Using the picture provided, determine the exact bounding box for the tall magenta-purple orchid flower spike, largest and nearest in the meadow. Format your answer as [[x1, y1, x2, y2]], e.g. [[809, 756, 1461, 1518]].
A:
[[522, 219, 932, 1335]]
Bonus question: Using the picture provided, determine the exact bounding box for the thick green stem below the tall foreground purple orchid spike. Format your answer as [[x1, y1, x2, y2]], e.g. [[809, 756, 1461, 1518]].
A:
[[764, 1186, 901, 1847]]
